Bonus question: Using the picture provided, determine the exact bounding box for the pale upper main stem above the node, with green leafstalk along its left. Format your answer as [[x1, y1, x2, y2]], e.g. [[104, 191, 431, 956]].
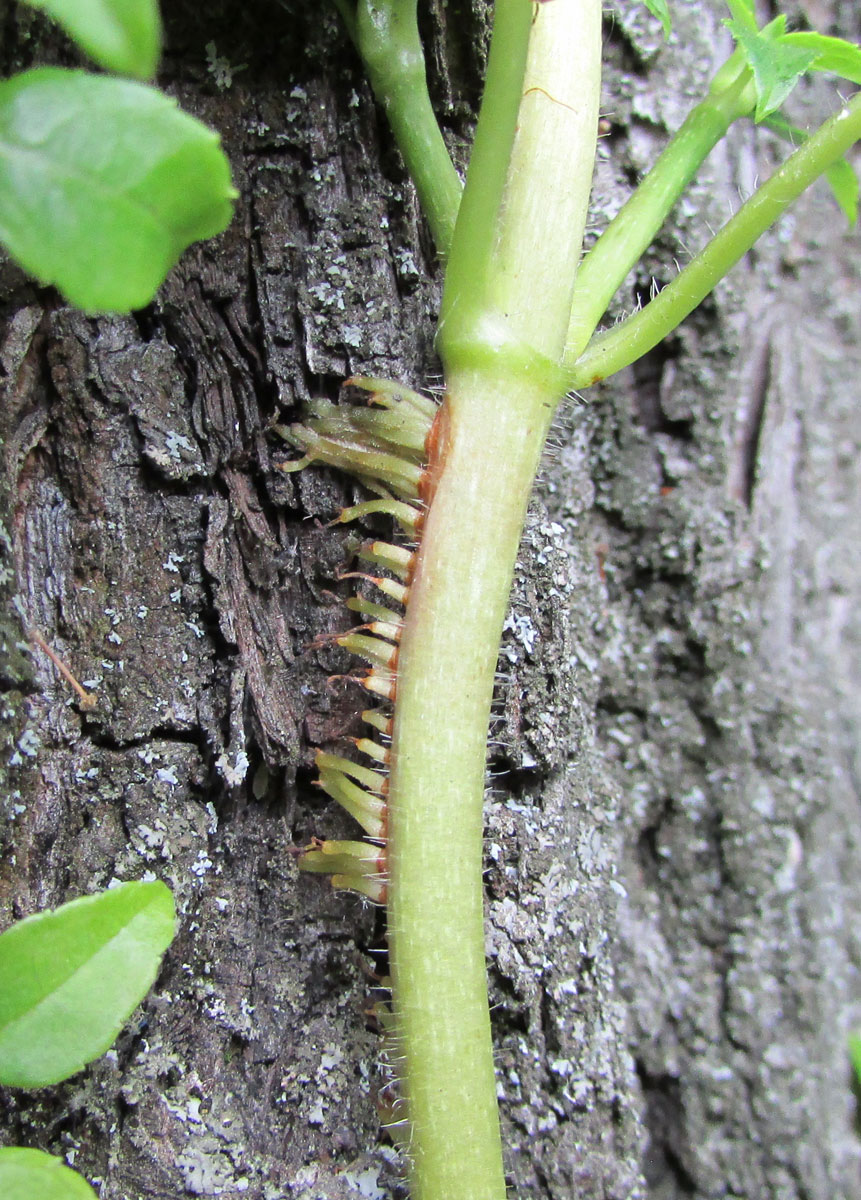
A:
[[436, 0, 601, 374]]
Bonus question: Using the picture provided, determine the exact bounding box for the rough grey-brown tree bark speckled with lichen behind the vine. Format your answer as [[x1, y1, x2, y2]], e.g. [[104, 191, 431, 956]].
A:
[[0, 0, 861, 1200]]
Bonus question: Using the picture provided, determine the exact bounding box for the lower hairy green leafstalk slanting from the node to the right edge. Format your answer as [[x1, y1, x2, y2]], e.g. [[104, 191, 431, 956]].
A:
[[567, 95, 861, 388]]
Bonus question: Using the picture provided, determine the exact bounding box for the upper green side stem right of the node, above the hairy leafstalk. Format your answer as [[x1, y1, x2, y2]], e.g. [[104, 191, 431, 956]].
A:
[[565, 50, 755, 365]]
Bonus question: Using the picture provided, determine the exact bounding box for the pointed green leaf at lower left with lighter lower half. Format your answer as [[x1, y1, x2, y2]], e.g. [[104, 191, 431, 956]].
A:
[[0, 883, 175, 1089]]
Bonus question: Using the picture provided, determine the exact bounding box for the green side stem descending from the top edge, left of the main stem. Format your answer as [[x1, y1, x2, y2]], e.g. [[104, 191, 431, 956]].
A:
[[354, 0, 462, 256]]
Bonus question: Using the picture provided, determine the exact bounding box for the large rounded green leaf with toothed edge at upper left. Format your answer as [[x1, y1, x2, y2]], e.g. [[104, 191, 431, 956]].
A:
[[0, 67, 236, 312]]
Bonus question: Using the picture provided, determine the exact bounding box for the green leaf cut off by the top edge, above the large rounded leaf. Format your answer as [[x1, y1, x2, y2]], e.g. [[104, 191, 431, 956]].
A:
[[19, 0, 162, 79]]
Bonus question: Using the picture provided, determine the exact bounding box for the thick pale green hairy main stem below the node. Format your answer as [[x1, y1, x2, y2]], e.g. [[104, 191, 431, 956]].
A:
[[389, 371, 555, 1200]]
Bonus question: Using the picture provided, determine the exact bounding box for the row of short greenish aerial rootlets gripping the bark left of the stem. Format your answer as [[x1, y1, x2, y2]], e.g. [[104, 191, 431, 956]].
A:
[[278, 378, 438, 902]]
